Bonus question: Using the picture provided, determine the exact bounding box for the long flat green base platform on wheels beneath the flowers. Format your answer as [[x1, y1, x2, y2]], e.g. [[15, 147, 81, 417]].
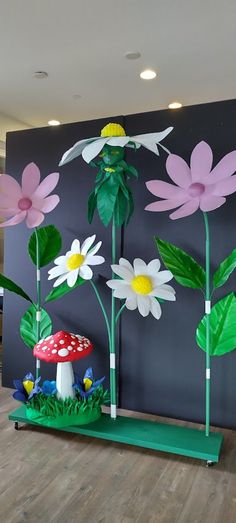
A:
[[9, 405, 223, 463]]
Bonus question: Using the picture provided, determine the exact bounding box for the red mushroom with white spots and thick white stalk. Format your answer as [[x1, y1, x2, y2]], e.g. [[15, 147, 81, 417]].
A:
[[34, 331, 93, 400]]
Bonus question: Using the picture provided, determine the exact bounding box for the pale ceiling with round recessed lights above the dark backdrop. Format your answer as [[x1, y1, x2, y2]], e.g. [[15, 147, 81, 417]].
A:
[[0, 0, 236, 140]]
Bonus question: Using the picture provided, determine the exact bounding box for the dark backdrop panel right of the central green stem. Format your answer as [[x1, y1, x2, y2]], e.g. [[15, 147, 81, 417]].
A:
[[120, 101, 236, 427]]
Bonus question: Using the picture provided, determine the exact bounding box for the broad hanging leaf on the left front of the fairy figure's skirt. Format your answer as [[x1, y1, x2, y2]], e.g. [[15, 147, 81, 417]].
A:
[[97, 175, 119, 226]]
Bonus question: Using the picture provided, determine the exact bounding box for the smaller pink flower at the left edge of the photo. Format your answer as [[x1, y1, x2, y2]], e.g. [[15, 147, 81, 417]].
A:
[[0, 163, 60, 229]]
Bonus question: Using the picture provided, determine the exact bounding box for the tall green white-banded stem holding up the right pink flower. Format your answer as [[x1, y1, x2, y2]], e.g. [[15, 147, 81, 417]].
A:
[[203, 212, 211, 436]]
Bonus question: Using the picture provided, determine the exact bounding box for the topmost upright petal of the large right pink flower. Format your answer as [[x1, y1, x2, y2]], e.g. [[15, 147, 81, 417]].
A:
[[190, 141, 213, 183]]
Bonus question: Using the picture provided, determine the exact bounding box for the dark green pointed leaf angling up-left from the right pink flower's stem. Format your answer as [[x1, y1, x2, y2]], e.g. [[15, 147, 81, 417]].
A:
[[155, 238, 206, 289]]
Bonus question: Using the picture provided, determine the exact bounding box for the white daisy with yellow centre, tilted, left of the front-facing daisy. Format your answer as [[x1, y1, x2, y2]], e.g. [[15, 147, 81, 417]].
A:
[[48, 234, 105, 287]]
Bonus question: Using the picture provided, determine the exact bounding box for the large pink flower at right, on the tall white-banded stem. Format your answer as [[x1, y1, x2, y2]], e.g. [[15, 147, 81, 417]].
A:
[[145, 142, 236, 220]]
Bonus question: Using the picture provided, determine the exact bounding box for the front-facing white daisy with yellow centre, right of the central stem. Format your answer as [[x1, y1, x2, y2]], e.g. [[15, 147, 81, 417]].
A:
[[107, 258, 176, 320]]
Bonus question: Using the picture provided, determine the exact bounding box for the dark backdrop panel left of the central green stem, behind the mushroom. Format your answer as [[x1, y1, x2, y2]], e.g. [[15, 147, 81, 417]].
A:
[[3, 117, 123, 386]]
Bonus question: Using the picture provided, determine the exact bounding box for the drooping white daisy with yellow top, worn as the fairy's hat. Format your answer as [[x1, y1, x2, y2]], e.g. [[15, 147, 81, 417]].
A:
[[59, 123, 173, 166]]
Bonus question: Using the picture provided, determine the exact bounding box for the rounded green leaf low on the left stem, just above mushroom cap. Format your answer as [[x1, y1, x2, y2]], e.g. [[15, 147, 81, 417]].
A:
[[20, 305, 52, 349]]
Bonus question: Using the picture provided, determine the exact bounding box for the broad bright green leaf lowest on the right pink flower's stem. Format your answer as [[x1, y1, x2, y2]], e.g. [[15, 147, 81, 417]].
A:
[[196, 293, 236, 356]]
